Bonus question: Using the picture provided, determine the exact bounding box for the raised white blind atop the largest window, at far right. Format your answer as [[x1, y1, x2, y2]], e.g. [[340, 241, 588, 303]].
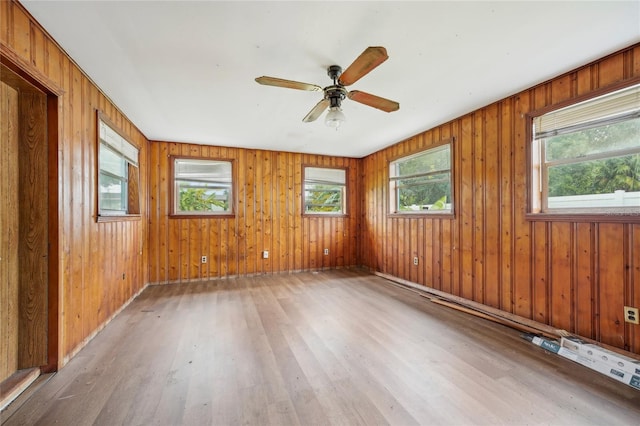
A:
[[533, 84, 640, 139]]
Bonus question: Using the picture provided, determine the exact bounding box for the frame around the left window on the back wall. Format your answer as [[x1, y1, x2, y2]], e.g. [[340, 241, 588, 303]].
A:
[[168, 155, 237, 219]]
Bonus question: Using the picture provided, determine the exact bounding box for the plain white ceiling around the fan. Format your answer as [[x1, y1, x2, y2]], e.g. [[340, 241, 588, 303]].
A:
[[23, 0, 640, 157]]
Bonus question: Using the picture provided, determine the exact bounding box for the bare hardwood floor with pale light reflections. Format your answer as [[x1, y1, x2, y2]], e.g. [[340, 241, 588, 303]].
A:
[[3, 270, 640, 425]]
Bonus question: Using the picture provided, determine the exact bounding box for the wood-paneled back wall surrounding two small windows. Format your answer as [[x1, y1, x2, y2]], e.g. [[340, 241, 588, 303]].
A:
[[149, 142, 359, 283]]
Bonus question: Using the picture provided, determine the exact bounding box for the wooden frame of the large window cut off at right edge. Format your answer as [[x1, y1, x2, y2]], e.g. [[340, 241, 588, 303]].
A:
[[525, 77, 640, 223]]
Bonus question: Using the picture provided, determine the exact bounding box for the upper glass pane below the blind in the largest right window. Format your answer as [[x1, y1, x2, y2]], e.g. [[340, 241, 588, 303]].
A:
[[545, 118, 640, 161]]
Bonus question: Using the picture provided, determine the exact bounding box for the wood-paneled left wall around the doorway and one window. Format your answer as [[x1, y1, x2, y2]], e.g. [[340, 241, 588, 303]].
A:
[[0, 1, 148, 366]]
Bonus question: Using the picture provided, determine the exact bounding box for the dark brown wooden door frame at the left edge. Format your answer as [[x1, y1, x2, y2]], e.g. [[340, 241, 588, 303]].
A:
[[0, 52, 64, 373]]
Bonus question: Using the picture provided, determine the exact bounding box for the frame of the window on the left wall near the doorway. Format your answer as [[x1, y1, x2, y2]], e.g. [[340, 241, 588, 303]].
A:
[[95, 111, 141, 222]]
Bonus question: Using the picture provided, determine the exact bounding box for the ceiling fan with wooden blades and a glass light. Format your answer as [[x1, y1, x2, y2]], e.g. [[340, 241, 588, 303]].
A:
[[256, 46, 400, 129]]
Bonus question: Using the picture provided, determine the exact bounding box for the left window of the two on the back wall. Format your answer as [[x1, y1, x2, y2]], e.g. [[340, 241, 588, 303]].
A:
[[172, 157, 233, 215]]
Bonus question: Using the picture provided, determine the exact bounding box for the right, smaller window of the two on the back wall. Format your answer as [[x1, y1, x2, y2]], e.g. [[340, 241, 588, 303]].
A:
[[303, 167, 347, 215]]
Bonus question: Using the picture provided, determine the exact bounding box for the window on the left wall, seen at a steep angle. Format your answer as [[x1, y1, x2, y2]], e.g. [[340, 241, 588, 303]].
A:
[[98, 117, 140, 216]]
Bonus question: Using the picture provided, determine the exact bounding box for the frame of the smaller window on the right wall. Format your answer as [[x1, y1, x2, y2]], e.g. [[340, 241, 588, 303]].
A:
[[386, 137, 457, 219]]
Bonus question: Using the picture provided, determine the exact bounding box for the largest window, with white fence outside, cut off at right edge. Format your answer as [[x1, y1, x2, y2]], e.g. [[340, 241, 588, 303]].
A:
[[531, 85, 640, 214]]
